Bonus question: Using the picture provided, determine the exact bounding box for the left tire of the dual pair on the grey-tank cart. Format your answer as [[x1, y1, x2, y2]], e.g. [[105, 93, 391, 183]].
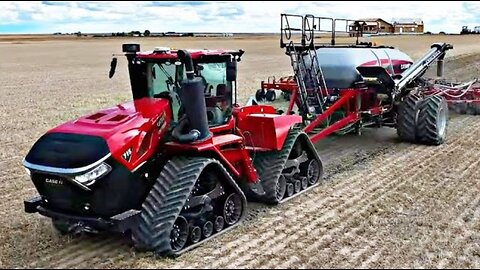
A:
[[397, 94, 422, 142]]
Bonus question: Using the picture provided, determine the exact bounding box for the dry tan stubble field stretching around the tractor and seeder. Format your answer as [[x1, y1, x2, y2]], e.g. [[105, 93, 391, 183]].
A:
[[0, 35, 480, 268]]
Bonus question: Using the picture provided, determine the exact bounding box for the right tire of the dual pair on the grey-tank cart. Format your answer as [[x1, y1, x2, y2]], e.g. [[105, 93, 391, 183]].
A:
[[417, 96, 448, 145]]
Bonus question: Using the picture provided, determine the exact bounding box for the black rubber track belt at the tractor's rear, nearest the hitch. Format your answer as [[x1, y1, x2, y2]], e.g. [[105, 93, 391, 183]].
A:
[[253, 128, 323, 204]]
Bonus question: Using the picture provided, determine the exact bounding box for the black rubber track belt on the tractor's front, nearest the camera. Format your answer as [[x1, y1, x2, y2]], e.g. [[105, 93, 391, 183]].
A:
[[132, 157, 246, 255]]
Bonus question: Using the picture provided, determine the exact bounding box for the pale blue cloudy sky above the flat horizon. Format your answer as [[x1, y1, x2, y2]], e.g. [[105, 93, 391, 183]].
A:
[[0, 1, 480, 34]]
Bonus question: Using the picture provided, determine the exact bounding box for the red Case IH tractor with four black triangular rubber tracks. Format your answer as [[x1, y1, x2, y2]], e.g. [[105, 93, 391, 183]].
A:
[[23, 44, 323, 255]]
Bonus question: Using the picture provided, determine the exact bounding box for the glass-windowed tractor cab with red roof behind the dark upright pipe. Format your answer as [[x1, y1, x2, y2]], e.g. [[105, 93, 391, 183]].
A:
[[115, 44, 243, 127]]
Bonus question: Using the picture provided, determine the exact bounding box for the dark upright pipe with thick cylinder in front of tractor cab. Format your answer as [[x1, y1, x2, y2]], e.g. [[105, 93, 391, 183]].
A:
[[172, 50, 210, 143]]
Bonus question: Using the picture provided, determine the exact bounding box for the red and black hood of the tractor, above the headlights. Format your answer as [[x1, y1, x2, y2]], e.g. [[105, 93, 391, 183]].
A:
[[24, 98, 171, 173]]
